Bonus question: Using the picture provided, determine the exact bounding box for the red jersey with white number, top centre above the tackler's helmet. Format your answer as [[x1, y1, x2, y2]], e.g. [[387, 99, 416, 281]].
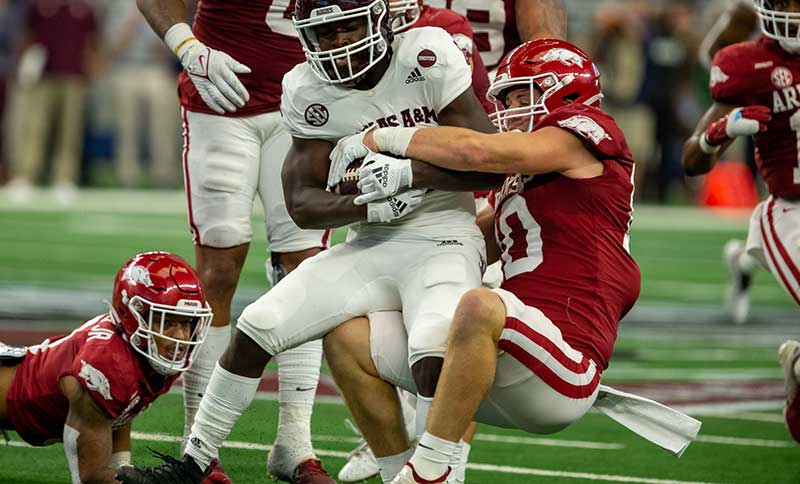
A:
[[425, 0, 522, 70]]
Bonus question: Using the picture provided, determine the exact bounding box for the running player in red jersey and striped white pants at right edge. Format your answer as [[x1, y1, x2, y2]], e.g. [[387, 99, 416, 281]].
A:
[[683, 0, 800, 446]]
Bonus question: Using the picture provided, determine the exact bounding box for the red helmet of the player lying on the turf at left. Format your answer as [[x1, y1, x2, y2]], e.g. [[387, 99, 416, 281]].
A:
[[111, 252, 212, 375]]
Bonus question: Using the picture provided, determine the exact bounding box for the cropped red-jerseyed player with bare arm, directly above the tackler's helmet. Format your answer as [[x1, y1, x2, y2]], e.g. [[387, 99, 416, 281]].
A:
[[426, 0, 567, 70]]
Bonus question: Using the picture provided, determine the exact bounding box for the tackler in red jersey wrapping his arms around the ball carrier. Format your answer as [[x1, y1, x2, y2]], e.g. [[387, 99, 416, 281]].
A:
[[325, 39, 640, 483]]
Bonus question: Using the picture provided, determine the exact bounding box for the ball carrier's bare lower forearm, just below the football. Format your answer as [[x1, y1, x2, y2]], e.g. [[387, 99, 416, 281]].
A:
[[286, 187, 367, 229]]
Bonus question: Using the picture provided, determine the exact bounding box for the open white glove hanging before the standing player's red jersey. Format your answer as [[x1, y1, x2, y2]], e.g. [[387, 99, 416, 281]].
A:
[[164, 24, 251, 114]]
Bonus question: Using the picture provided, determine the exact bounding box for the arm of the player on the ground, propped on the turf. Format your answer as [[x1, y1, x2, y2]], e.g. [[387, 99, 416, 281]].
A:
[[59, 376, 117, 484]]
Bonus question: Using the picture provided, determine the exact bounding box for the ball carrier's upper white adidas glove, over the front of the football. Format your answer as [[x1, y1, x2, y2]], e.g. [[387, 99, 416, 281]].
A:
[[354, 153, 414, 205]]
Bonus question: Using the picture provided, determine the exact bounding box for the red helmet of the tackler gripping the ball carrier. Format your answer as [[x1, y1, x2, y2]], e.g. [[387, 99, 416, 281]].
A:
[[486, 39, 603, 131]]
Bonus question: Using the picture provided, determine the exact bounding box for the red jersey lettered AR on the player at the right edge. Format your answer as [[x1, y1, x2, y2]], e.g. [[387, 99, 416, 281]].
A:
[[709, 35, 800, 200]]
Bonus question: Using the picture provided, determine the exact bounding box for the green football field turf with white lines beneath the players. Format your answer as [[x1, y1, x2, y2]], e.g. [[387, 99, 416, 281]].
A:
[[0, 191, 800, 484]]
